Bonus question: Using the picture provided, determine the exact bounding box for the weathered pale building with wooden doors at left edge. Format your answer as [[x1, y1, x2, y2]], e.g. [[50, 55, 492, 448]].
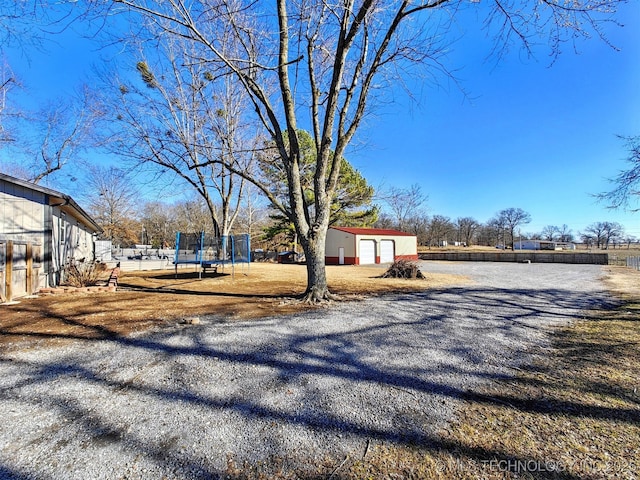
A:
[[0, 173, 102, 301]]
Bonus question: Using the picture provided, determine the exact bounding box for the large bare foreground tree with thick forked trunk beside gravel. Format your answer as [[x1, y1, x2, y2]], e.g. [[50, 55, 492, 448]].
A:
[[100, 0, 616, 301]]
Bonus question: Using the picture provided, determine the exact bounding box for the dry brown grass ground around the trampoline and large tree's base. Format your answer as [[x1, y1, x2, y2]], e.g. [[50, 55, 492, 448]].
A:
[[0, 263, 468, 349]]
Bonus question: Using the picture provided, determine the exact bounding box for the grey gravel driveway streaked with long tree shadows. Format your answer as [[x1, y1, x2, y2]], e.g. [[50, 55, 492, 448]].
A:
[[0, 263, 611, 480]]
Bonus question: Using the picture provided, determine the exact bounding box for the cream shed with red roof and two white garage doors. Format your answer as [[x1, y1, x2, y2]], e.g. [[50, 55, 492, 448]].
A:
[[325, 227, 418, 265]]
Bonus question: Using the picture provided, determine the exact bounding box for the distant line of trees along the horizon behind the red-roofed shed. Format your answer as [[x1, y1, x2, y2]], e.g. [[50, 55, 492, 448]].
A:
[[75, 169, 637, 251]]
